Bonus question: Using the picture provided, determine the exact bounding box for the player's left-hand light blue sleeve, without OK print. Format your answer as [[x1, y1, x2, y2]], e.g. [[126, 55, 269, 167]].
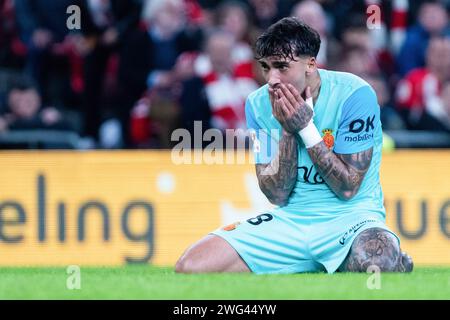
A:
[[245, 98, 278, 164]]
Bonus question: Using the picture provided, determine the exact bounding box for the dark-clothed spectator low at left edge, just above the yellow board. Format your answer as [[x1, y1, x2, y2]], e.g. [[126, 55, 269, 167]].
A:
[[0, 79, 72, 131]]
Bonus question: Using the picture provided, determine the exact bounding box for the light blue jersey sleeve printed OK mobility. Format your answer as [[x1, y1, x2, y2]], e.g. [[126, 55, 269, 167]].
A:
[[334, 86, 381, 154]]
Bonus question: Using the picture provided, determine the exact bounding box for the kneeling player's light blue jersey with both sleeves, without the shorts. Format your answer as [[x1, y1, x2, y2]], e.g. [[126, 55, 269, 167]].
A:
[[245, 69, 385, 216]]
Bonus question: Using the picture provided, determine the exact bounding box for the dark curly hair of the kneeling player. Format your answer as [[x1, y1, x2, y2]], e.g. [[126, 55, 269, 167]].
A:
[[255, 17, 320, 60]]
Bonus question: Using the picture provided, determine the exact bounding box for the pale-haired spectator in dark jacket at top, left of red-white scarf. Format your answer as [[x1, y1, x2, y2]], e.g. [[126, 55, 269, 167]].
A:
[[119, 0, 202, 148]]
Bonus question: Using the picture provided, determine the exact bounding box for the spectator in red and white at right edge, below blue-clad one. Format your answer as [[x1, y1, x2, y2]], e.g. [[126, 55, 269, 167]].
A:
[[396, 37, 450, 130]]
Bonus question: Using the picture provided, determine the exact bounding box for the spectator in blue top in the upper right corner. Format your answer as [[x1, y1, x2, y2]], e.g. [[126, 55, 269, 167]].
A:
[[397, 1, 450, 77]]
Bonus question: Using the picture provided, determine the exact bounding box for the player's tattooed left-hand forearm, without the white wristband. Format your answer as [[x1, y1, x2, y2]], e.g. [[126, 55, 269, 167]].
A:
[[256, 132, 298, 206]]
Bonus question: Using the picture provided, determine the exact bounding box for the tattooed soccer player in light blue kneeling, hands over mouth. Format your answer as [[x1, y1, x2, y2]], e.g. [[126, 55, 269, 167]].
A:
[[175, 18, 413, 273]]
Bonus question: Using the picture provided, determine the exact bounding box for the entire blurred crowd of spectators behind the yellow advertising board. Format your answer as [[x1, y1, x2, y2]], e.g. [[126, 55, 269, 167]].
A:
[[0, 0, 450, 149]]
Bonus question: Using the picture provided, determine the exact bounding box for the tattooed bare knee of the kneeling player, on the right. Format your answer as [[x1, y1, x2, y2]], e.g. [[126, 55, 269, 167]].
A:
[[340, 228, 412, 272]]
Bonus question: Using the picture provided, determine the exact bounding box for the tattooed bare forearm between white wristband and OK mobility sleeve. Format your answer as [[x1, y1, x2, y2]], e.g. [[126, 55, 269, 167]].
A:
[[308, 141, 372, 200]]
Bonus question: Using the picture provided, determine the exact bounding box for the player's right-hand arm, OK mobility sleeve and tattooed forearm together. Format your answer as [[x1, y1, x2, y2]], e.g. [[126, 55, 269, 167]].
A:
[[307, 86, 381, 200]]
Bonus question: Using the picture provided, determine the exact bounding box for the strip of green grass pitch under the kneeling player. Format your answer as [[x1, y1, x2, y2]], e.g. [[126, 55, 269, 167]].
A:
[[0, 266, 450, 300]]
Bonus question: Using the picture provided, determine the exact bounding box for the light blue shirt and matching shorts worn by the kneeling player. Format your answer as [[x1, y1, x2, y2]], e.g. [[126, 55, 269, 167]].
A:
[[212, 69, 398, 273]]
